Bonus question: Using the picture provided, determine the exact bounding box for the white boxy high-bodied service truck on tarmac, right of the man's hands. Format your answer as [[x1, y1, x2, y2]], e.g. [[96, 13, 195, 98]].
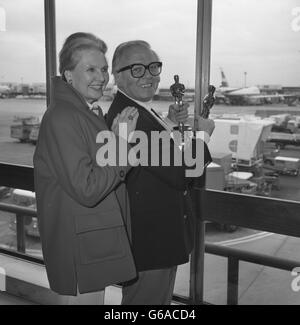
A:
[[209, 116, 279, 196]]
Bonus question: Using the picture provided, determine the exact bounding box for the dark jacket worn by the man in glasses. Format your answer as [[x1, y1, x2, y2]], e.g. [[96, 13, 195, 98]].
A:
[[107, 92, 211, 271]]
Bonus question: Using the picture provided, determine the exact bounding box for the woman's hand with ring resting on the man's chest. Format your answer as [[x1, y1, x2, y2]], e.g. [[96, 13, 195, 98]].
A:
[[111, 107, 139, 140]]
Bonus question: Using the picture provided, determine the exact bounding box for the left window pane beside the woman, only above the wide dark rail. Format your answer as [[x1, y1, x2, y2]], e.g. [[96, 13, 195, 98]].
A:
[[0, 0, 46, 165]]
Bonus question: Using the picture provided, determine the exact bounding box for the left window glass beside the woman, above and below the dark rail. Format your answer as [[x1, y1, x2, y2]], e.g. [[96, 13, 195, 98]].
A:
[[0, 0, 46, 257]]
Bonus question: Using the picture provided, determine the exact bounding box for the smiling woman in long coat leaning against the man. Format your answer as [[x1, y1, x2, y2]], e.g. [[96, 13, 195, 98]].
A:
[[34, 33, 138, 304]]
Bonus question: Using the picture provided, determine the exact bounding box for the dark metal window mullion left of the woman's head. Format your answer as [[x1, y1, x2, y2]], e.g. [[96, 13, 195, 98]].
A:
[[44, 0, 57, 105]]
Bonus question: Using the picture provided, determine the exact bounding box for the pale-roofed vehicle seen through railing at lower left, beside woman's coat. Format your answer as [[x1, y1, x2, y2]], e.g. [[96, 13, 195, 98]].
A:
[[10, 189, 40, 237]]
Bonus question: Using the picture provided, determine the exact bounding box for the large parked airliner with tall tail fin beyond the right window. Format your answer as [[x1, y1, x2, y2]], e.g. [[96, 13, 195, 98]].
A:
[[216, 69, 300, 106]]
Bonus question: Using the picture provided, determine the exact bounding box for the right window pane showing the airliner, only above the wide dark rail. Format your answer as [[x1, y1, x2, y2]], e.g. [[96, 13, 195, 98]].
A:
[[208, 0, 300, 201]]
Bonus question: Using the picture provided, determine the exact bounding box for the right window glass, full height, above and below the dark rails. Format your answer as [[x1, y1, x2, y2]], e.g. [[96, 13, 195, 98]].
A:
[[205, 0, 300, 304]]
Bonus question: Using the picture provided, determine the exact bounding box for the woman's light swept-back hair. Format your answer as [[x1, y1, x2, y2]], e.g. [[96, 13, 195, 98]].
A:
[[59, 33, 107, 80]]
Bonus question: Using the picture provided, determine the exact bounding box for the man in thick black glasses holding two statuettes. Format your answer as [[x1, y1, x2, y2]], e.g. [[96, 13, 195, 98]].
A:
[[107, 41, 214, 305]]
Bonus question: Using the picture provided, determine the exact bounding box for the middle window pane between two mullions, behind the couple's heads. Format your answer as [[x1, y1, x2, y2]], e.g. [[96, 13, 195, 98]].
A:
[[56, 0, 197, 295]]
